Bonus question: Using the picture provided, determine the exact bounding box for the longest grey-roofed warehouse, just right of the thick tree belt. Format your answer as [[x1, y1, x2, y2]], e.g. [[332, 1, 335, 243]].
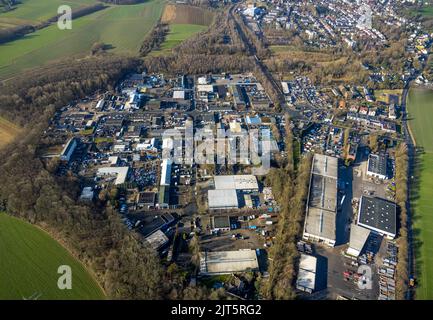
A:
[[303, 154, 338, 247]]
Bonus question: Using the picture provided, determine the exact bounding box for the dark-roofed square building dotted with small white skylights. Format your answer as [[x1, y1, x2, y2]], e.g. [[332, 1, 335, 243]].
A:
[[357, 196, 397, 239]]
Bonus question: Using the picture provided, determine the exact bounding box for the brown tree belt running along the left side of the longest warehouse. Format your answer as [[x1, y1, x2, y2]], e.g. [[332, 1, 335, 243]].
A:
[[260, 116, 311, 300]]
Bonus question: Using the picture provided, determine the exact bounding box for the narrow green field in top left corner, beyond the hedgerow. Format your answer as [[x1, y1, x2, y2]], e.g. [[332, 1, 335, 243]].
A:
[[0, 0, 97, 29]]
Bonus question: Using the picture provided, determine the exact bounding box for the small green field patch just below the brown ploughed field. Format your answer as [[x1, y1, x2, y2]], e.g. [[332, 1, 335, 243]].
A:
[[152, 24, 208, 55]]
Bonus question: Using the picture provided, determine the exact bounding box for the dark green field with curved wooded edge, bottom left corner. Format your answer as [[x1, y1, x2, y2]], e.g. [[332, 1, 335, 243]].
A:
[[0, 212, 105, 300]]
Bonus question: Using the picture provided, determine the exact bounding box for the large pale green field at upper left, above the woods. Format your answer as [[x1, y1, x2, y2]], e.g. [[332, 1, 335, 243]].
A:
[[0, 0, 164, 79]]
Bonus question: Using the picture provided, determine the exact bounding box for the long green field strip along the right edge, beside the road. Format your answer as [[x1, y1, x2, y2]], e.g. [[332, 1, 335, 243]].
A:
[[407, 89, 433, 300]]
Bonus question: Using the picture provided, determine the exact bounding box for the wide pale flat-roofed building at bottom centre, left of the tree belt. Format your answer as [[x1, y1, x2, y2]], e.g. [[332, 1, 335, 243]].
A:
[[200, 249, 259, 275]]
